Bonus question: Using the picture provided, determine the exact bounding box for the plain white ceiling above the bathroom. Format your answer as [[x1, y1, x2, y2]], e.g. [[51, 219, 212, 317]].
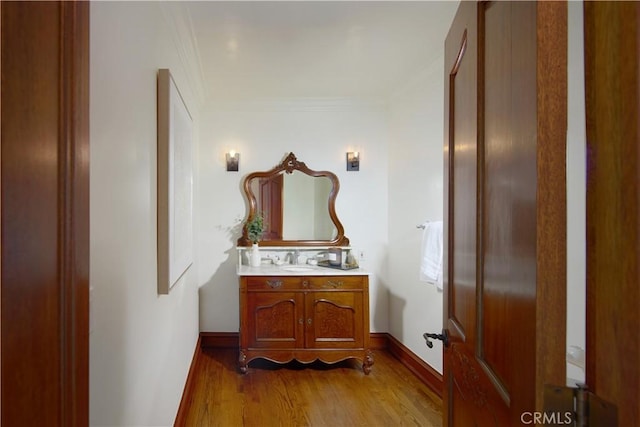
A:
[[186, 1, 458, 100]]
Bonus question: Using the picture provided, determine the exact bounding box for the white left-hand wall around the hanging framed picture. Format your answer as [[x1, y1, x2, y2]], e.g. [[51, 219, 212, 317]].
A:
[[90, 2, 198, 426]]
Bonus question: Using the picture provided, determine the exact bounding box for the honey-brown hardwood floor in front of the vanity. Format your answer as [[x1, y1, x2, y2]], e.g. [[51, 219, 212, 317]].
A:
[[183, 349, 442, 427]]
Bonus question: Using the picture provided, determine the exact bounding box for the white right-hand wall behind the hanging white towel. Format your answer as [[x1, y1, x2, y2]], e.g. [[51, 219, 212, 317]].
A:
[[388, 57, 444, 372]]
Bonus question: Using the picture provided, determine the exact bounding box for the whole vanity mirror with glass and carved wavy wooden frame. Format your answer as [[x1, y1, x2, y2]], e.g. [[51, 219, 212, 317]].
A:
[[238, 153, 349, 246]]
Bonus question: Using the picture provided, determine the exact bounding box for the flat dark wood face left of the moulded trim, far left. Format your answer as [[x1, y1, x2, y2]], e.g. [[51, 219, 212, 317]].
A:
[[2, 2, 63, 425]]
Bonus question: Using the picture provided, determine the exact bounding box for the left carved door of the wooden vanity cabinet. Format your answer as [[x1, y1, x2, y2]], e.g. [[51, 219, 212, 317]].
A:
[[246, 292, 304, 348]]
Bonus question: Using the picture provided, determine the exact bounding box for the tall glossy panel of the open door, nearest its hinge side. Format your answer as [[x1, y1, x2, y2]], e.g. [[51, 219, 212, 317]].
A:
[[480, 2, 537, 404]]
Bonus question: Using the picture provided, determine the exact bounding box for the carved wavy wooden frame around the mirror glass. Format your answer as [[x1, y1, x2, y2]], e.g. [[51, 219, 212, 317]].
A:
[[238, 153, 349, 246]]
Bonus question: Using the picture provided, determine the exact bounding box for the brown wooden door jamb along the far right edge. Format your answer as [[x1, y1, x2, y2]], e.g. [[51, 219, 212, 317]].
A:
[[584, 2, 640, 426]]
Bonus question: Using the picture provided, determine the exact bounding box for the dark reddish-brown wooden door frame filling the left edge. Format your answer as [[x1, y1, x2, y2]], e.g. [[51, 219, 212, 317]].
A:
[[0, 2, 89, 427]]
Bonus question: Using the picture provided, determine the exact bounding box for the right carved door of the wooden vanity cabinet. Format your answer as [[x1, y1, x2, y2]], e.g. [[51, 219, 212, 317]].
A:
[[305, 291, 364, 348]]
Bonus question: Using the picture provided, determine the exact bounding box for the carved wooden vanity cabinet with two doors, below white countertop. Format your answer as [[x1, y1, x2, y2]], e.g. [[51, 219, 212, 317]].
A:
[[239, 275, 373, 374]]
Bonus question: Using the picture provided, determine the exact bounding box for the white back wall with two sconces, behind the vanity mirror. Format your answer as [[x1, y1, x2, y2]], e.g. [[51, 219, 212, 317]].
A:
[[196, 99, 389, 332]]
